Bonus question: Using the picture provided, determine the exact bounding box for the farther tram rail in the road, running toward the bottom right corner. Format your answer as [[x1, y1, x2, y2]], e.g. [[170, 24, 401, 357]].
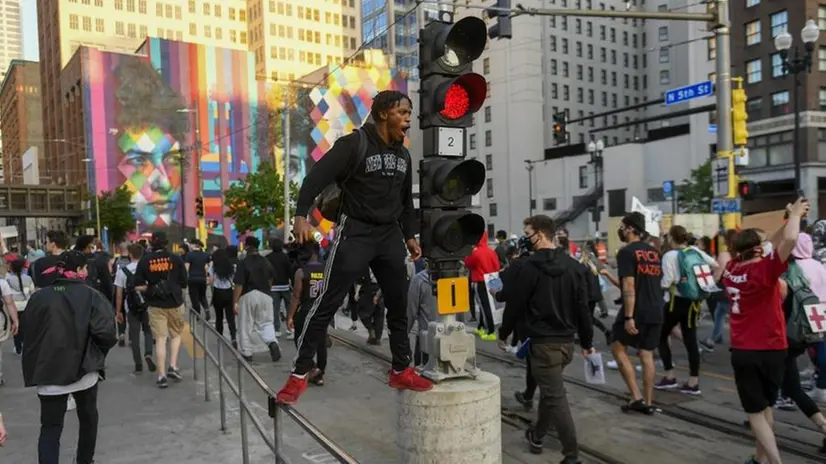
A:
[[476, 349, 826, 462]]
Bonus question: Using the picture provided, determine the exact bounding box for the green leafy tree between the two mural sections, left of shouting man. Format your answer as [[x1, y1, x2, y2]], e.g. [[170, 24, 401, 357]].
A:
[[224, 163, 298, 234]]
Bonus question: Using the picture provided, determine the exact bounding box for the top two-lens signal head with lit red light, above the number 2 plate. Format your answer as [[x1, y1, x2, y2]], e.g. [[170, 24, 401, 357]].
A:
[[419, 17, 488, 129]]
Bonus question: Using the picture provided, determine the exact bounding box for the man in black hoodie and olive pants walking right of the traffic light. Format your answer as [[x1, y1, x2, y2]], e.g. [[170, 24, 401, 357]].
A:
[[503, 215, 594, 464]]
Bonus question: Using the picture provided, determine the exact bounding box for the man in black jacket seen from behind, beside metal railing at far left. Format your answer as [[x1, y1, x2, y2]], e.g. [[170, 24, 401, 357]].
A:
[[22, 250, 117, 464]]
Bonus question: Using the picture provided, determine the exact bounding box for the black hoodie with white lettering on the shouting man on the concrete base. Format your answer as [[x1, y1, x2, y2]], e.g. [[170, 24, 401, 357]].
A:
[[295, 123, 416, 239]]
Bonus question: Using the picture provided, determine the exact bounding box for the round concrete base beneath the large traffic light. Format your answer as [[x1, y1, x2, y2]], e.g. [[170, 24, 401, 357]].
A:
[[396, 372, 502, 464]]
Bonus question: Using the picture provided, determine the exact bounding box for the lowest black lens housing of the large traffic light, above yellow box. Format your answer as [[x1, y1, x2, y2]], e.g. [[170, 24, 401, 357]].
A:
[[421, 209, 486, 261]]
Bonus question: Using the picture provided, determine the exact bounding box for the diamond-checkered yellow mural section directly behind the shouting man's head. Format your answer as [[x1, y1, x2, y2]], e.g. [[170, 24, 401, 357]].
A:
[[278, 65, 407, 235]]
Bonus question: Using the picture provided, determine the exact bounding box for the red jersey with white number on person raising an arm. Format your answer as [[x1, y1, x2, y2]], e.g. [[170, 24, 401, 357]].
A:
[[723, 251, 789, 350]]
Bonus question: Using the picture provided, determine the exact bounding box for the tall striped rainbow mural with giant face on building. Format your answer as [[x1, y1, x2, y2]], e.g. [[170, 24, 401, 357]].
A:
[[82, 38, 268, 242]]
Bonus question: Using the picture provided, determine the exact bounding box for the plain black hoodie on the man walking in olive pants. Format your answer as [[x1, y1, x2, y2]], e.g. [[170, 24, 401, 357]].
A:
[[502, 248, 594, 349]]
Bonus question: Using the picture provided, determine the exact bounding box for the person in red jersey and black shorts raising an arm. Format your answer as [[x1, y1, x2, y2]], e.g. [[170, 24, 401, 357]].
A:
[[723, 197, 809, 464]]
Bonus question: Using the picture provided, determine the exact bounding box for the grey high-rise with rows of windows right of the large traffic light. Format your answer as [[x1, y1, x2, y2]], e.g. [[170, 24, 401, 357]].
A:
[[458, 0, 714, 236]]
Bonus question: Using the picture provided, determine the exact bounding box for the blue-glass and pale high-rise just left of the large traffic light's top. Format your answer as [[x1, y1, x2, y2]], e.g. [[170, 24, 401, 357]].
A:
[[360, 0, 452, 79]]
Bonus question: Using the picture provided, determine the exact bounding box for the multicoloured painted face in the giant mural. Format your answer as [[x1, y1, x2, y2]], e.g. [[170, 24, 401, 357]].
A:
[[118, 126, 182, 227]]
